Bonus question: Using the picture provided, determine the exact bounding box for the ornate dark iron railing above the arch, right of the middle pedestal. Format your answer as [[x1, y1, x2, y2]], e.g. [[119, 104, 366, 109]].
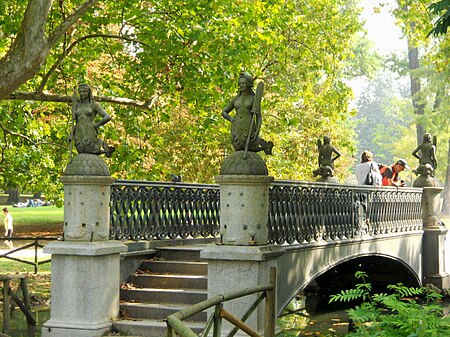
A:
[[269, 181, 422, 244]]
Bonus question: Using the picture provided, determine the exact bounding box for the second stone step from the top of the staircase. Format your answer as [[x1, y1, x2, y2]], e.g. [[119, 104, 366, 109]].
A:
[[140, 260, 208, 276]]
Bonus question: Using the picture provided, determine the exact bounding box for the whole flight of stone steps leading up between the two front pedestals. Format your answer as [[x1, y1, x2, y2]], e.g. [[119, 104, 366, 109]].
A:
[[113, 245, 208, 337]]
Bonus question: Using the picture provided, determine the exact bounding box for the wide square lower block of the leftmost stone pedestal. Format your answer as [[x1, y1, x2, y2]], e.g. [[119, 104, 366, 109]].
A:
[[42, 241, 126, 337]]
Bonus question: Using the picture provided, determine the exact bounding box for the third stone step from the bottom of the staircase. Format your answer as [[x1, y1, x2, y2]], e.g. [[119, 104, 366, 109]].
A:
[[120, 288, 208, 305]]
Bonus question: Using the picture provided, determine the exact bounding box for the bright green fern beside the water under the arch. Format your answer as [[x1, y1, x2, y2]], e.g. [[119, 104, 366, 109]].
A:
[[329, 272, 450, 337]]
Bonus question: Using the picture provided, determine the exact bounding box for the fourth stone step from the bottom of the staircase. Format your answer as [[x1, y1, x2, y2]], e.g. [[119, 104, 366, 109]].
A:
[[131, 273, 208, 289]]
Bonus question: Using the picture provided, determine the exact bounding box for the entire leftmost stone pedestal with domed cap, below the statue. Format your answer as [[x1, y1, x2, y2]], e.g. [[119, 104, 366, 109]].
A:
[[42, 154, 127, 337]]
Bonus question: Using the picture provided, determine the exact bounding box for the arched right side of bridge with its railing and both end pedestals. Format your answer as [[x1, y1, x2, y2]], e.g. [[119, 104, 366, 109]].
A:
[[201, 177, 450, 331]]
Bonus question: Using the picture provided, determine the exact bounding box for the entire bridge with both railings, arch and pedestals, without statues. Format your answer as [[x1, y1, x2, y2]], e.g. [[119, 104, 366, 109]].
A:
[[42, 172, 450, 337]]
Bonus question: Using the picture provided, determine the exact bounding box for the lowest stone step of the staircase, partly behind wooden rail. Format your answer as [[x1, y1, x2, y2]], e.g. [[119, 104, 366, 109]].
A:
[[113, 319, 205, 337]]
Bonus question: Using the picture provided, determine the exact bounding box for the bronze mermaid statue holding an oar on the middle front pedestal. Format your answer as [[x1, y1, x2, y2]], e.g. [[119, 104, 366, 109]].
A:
[[222, 73, 273, 158]]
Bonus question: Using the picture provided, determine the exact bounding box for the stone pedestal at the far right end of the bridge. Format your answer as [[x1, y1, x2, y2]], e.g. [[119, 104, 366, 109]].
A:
[[422, 187, 450, 289]]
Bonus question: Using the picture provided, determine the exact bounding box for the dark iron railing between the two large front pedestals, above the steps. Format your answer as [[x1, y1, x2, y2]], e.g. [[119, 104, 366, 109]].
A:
[[110, 180, 220, 240]]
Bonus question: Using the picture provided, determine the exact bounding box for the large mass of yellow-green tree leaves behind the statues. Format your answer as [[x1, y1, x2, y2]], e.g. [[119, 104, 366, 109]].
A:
[[0, 0, 370, 189]]
